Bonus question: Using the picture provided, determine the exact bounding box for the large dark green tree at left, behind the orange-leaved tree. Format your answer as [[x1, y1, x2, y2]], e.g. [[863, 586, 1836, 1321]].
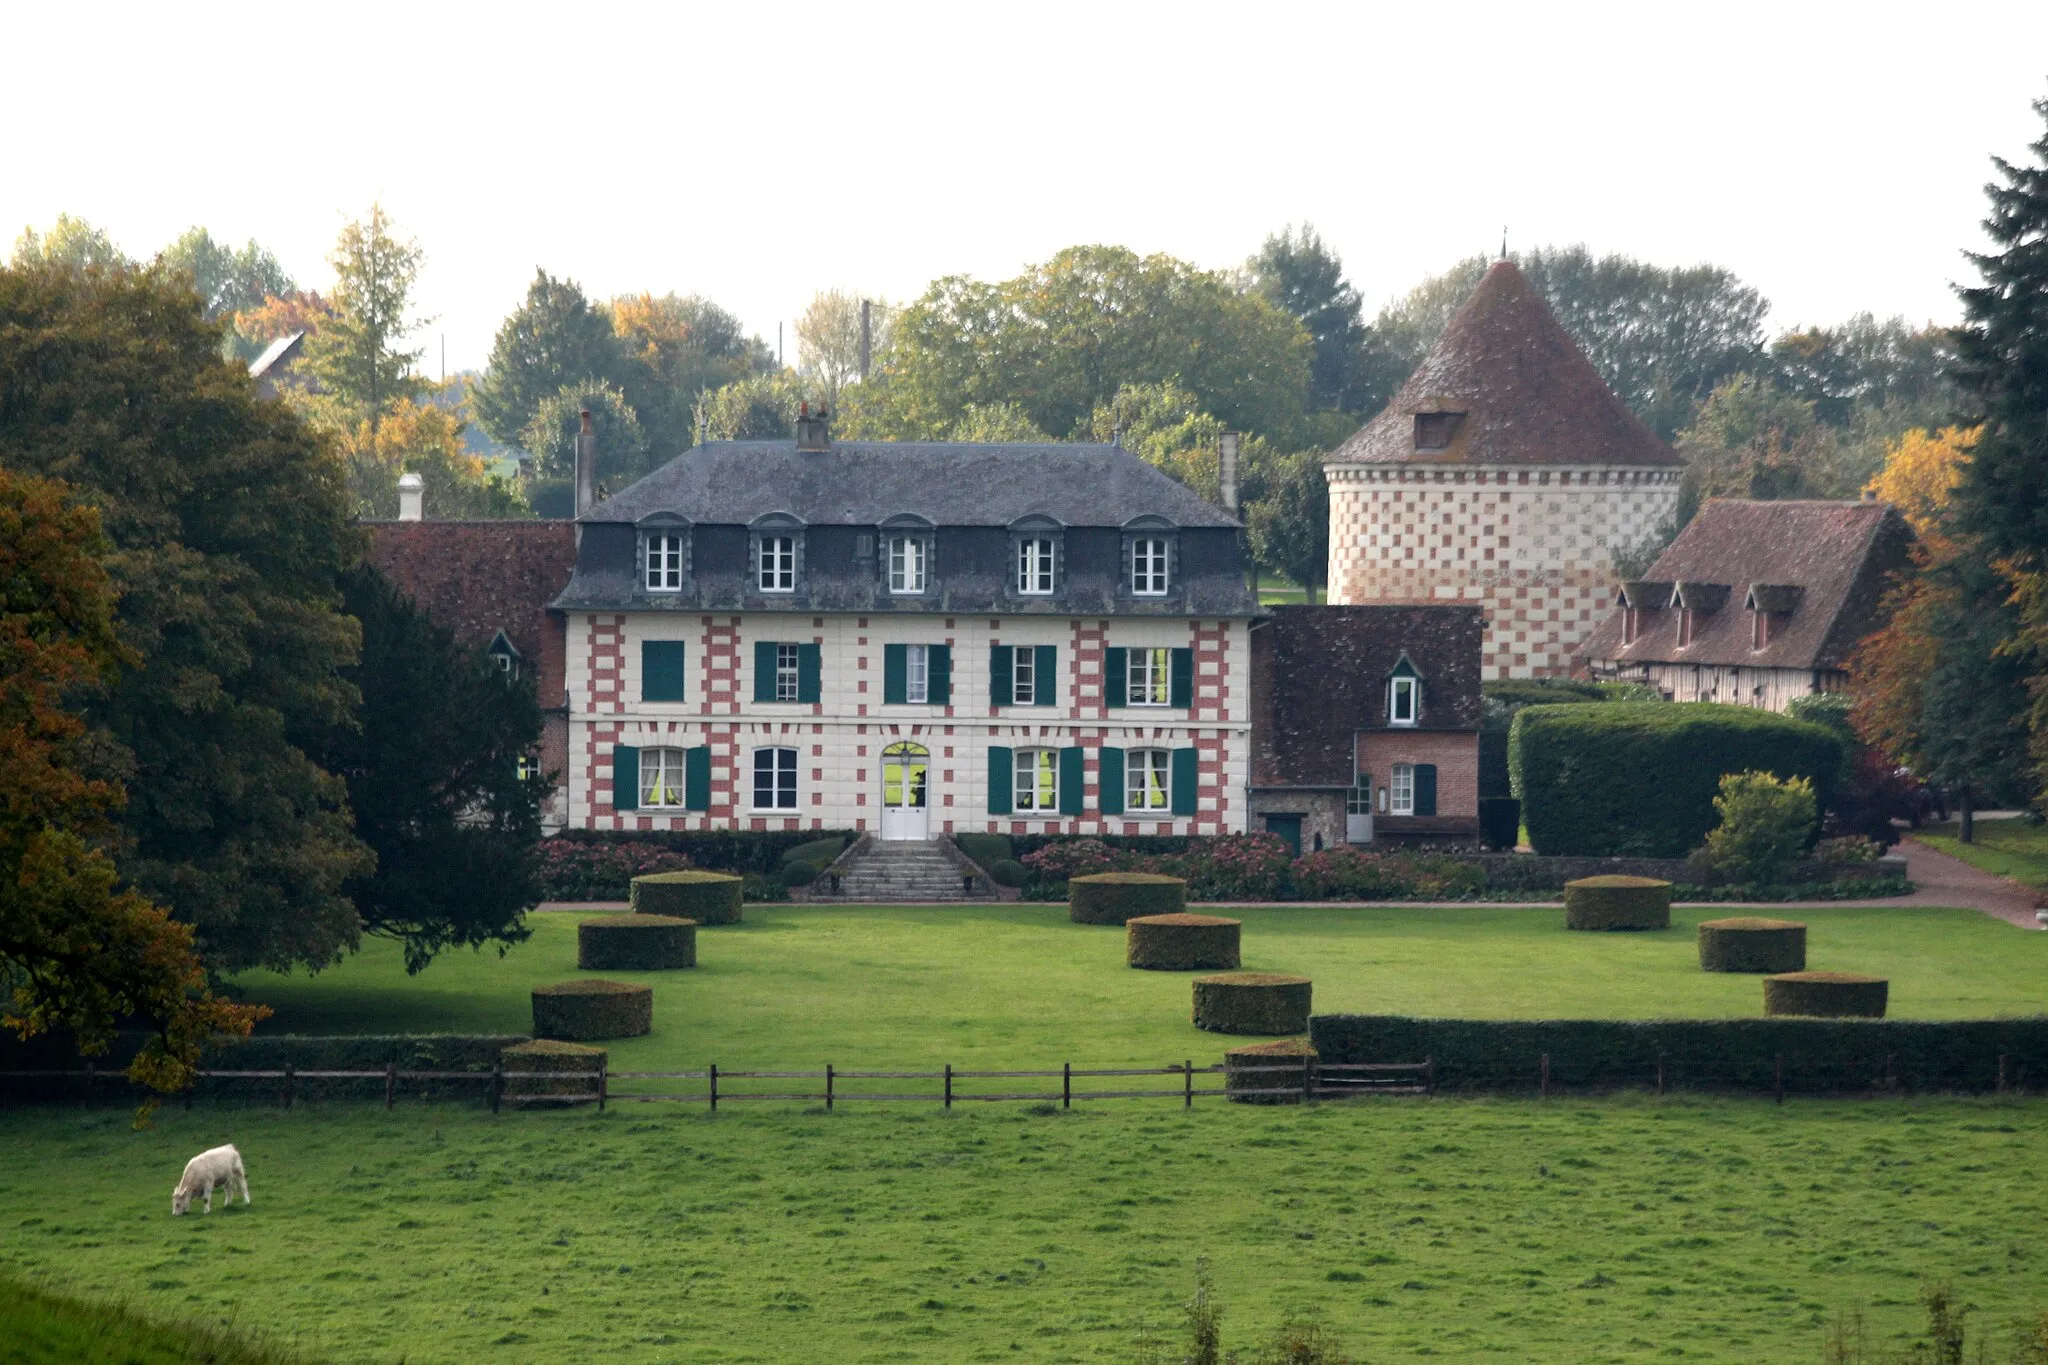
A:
[[0, 255, 369, 970]]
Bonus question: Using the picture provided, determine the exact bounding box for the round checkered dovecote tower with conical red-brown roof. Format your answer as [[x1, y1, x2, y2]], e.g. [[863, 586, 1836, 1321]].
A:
[[1323, 260, 1683, 677]]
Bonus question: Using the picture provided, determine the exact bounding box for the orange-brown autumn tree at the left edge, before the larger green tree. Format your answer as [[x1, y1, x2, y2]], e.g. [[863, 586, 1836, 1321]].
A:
[[0, 469, 268, 1091]]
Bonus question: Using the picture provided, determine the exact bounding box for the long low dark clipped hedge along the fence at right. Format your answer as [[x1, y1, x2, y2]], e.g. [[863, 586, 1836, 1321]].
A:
[[1309, 1015, 2048, 1091]]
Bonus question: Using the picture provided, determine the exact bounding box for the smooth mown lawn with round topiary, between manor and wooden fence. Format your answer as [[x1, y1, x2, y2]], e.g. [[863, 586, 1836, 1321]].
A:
[[224, 905, 2048, 1070]]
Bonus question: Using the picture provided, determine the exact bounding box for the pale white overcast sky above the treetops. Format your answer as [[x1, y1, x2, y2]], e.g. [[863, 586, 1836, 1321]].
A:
[[0, 0, 2048, 372]]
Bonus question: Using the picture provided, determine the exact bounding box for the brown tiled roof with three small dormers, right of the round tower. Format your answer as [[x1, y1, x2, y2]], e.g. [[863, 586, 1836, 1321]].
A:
[[1581, 499, 1913, 669]]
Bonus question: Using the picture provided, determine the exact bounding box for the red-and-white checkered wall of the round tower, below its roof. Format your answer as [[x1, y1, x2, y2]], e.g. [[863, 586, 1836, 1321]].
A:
[[1323, 465, 1679, 677]]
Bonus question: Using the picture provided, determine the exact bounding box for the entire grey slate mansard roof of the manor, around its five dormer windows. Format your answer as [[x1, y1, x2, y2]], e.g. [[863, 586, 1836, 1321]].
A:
[[555, 440, 1257, 616]]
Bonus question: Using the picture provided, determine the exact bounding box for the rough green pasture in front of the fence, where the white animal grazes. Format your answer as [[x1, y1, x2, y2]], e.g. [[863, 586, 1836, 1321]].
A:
[[0, 1097, 2048, 1365]]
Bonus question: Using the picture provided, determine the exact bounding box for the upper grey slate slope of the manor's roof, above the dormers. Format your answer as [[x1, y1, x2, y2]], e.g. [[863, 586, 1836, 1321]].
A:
[[582, 440, 1237, 526]]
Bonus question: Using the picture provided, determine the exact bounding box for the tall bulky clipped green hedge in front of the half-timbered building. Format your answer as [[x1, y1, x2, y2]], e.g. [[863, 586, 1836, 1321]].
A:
[[1507, 702, 1841, 857]]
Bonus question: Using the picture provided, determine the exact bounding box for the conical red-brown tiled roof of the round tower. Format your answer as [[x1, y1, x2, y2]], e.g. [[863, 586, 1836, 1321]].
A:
[[1329, 260, 1683, 467]]
